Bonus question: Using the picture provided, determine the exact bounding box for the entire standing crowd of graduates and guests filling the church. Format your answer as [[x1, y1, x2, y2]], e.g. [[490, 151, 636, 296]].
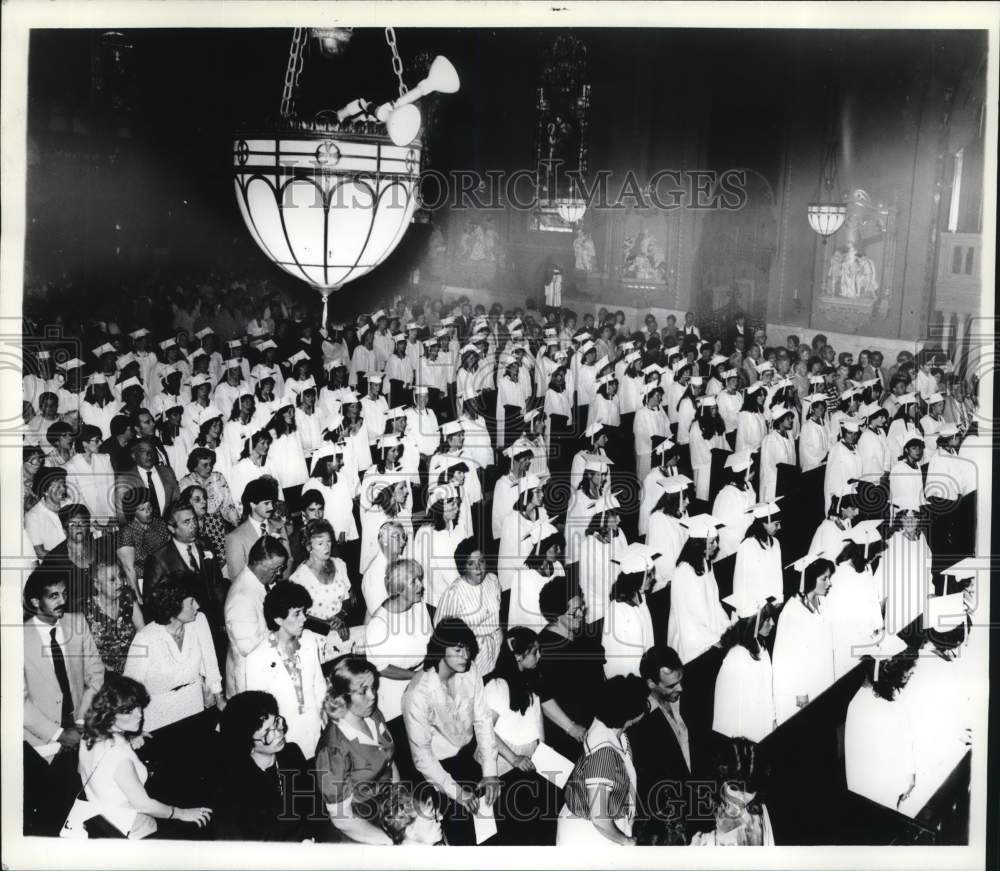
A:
[[23, 284, 977, 848]]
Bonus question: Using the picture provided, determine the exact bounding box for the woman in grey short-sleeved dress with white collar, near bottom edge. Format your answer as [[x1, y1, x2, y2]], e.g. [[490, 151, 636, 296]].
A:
[[316, 654, 399, 844]]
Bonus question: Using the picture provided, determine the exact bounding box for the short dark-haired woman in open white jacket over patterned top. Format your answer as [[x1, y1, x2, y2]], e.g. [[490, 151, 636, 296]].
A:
[[246, 581, 326, 760]]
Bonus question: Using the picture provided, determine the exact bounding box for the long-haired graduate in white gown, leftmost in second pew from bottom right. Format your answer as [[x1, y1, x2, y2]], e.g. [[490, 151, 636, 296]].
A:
[[712, 608, 780, 741]]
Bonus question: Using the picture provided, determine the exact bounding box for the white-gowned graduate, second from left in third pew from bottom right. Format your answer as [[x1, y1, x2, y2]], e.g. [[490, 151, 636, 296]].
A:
[[667, 514, 730, 664]]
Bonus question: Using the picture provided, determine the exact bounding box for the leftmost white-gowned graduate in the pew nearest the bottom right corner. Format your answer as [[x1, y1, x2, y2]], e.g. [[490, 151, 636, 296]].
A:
[[844, 635, 917, 810]]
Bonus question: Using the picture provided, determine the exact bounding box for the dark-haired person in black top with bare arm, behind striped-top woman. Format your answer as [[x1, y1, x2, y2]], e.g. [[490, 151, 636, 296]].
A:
[[538, 576, 604, 760]]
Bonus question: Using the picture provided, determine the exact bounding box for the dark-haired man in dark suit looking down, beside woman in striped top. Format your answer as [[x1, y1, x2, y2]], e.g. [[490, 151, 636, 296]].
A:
[[627, 645, 714, 843]]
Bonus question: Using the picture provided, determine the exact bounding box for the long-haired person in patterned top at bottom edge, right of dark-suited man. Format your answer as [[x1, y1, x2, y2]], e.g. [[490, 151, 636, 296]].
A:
[[691, 738, 774, 847]]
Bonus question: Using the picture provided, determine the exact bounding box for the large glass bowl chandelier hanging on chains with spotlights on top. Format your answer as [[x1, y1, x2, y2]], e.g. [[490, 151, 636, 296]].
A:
[[233, 27, 460, 328]]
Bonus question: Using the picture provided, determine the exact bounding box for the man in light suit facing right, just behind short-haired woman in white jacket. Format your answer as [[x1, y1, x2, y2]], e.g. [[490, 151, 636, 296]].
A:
[[225, 535, 288, 698]]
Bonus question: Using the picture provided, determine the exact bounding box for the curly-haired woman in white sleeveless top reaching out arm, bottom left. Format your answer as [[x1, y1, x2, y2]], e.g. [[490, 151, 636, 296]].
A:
[[78, 674, 212, 838]]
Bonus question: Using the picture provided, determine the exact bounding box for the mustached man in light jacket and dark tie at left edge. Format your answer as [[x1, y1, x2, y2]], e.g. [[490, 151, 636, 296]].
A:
[[24, 571, 104, 750]]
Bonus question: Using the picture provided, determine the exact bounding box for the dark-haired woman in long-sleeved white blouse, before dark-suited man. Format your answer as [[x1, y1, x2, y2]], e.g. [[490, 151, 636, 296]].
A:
[[124, 573, 225, 730]]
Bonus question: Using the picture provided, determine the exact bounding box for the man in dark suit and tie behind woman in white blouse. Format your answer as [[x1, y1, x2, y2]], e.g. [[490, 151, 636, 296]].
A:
[[143, 500, 229, 662]]
